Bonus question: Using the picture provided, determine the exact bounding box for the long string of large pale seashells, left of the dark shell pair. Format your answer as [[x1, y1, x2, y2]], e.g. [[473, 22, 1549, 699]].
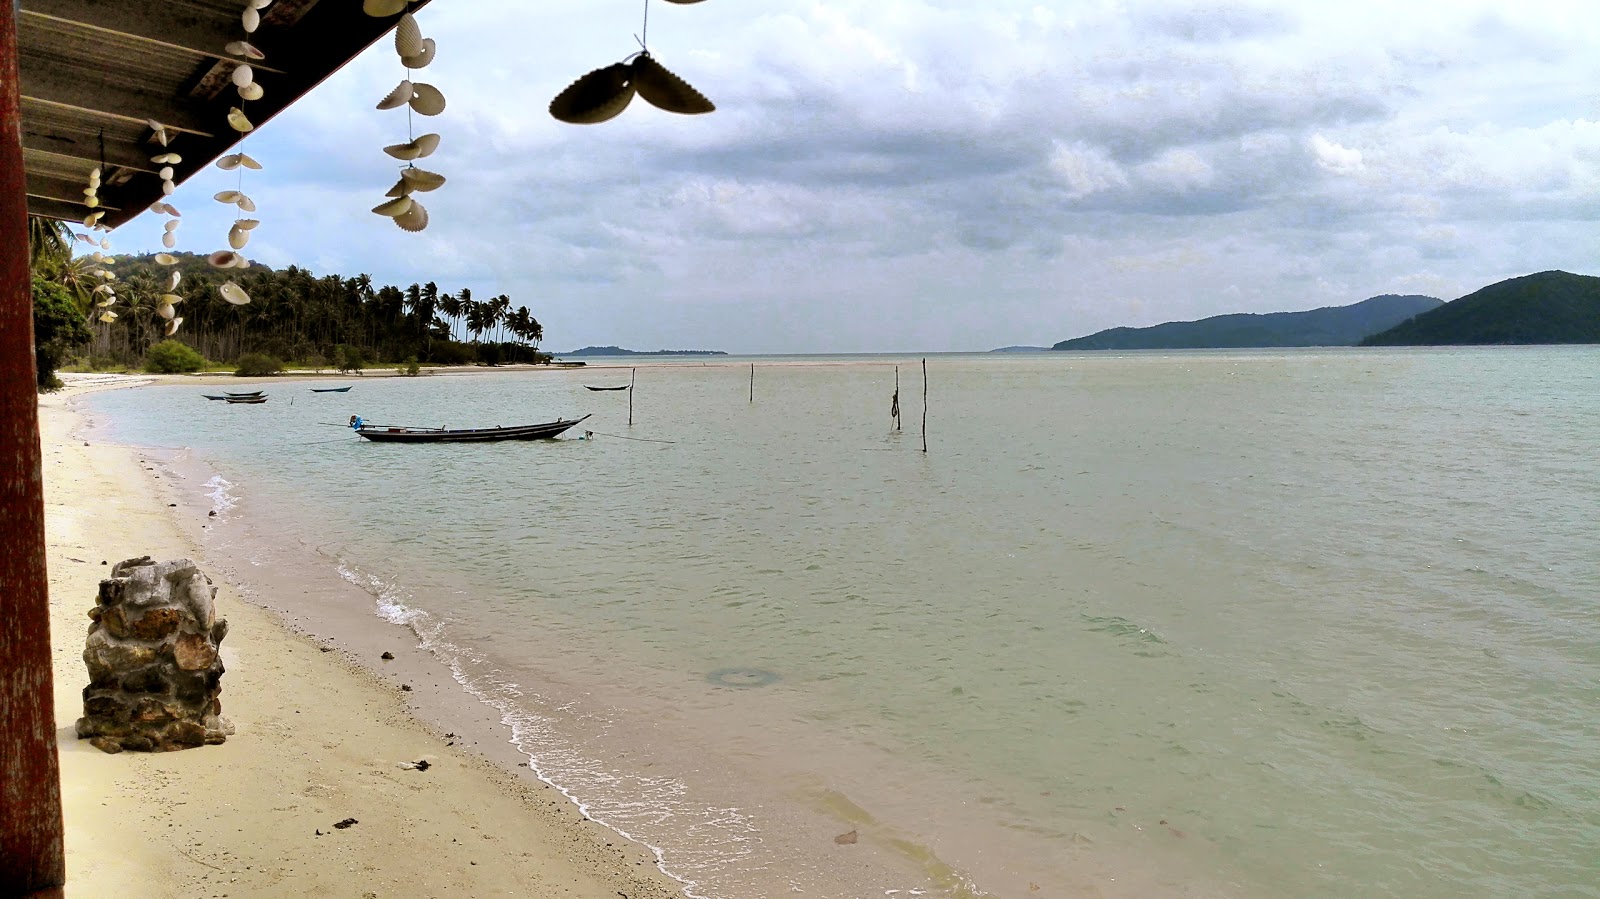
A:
[[362, 0, 445, 232]]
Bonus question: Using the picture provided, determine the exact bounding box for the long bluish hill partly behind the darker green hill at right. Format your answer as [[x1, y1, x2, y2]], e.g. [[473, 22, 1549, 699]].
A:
[[1051, 294, 1445, 350]]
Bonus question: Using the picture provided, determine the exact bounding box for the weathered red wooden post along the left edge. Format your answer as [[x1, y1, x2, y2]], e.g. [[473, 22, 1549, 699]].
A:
[[0, 0, 67, 897]]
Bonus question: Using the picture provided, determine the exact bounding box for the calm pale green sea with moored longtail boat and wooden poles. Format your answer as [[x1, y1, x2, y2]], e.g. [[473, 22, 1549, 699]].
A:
[[82, 347, 1600, 899]]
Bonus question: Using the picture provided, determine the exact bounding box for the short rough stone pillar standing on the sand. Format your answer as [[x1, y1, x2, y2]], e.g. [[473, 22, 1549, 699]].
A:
[[77, 557, 234, 752]]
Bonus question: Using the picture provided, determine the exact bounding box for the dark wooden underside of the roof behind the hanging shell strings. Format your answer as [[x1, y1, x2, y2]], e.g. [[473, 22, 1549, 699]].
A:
[[17, 0, 427, 227]]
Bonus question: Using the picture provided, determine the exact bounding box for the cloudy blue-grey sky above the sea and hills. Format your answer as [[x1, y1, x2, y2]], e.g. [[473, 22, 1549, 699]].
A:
[[114, 0, 1600, 354]]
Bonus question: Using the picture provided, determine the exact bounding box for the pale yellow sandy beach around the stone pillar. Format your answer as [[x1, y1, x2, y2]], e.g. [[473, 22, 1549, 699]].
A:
[[40, 378, 682, 899]]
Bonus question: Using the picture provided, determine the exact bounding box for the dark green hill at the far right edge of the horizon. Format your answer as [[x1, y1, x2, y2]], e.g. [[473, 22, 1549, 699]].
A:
[[1362, 272, 1600, 347]]
